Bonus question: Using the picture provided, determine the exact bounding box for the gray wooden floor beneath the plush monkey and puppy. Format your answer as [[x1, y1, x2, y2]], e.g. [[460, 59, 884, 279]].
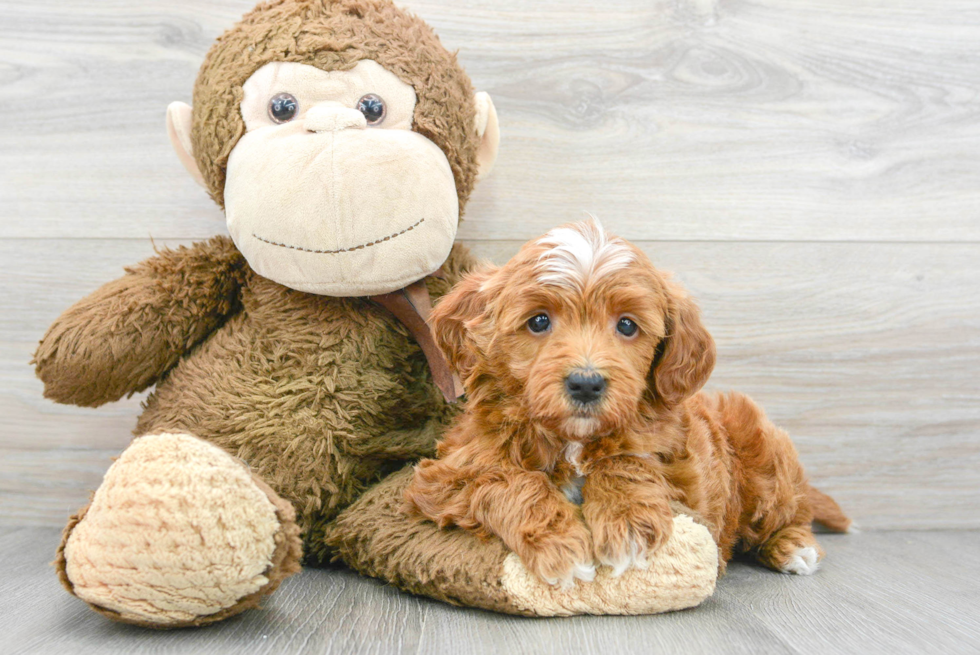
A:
[[0, 527, 980, 655]]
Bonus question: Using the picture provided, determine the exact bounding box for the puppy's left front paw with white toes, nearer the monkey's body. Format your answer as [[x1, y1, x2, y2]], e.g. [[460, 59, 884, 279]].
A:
[[517, 522, 595, 589]]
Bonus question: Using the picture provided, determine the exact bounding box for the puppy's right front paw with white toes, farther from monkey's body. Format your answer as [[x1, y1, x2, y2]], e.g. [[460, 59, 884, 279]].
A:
[[589, 507, 674, 577]]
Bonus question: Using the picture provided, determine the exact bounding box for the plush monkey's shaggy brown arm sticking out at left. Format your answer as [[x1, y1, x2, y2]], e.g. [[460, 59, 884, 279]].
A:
[[32, 237, 245, 407]]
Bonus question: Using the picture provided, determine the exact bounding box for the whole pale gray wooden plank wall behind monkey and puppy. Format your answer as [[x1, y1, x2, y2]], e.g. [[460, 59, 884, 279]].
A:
[[0, 0, 980, 529]]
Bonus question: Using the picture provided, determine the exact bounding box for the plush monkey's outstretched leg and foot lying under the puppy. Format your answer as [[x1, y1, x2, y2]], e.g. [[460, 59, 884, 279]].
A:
[[326, 466, 718, 616]]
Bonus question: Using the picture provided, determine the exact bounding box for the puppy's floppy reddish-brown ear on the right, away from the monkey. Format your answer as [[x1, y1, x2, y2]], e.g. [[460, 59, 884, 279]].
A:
[[650, 282, 715, 407]]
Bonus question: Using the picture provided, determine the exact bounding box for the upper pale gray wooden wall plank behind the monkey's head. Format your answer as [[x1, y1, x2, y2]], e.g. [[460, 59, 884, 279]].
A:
[[0, 0, 980, 241]]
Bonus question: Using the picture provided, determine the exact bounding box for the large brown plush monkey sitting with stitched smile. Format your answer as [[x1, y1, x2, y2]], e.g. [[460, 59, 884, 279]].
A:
[[35, 0, 716, 627]]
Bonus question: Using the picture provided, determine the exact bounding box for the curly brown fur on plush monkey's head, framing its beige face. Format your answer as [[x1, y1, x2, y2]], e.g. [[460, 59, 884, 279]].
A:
[[192, 0, 478, 214]]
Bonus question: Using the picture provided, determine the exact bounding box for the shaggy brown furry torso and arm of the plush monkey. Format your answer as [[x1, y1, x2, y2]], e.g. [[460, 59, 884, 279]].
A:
[[35, 237, 473, 561]]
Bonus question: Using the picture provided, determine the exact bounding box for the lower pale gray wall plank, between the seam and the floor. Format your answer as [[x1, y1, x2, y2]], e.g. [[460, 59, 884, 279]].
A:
[[0, 238, 980, 529]]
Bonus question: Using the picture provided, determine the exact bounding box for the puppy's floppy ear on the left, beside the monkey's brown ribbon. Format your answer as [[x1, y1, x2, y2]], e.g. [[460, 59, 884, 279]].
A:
[[429, 269, 495, 382]]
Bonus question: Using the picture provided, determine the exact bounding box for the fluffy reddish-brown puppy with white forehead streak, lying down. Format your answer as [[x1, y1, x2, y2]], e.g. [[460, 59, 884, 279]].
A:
[[406, 221, 850, 585]]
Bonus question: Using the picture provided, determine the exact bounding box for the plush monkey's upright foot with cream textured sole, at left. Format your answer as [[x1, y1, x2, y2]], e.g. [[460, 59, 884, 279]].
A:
[[55, 434, 302, 628]]
